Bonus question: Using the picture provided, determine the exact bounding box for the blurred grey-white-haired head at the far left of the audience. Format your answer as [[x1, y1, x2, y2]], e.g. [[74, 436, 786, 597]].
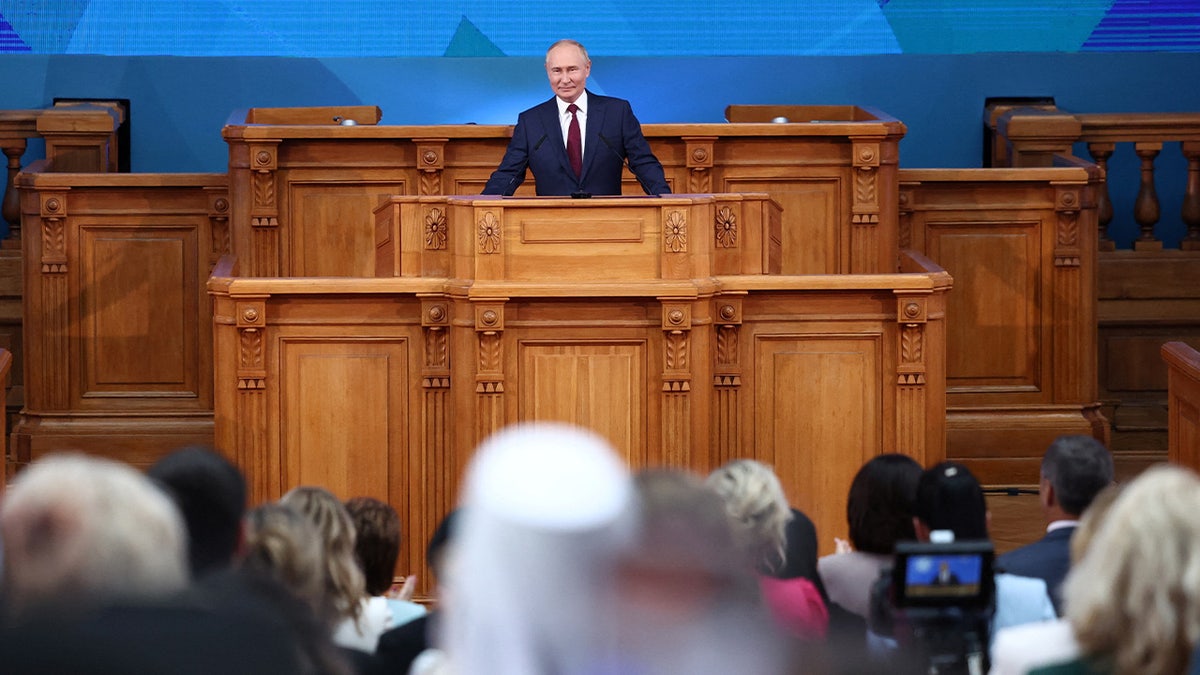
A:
[[0, 454, 187, 613]]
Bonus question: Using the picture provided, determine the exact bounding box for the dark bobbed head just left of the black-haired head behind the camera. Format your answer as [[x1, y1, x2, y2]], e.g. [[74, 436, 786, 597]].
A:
[[846, 454, 923, 555]]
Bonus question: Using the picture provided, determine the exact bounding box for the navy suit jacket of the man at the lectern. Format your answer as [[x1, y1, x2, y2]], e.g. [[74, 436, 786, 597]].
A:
[[484, 91, 671, 196]]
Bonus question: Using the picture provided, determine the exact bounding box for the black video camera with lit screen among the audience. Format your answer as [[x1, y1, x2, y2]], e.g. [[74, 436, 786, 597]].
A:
[[870, 539, 996, 674]]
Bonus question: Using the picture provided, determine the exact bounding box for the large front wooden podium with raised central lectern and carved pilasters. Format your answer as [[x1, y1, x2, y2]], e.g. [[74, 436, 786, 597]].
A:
[[209, 195, 950, 583]]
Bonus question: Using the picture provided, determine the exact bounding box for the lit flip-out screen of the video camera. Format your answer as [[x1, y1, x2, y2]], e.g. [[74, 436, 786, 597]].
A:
[[892, 542, 995, 609]]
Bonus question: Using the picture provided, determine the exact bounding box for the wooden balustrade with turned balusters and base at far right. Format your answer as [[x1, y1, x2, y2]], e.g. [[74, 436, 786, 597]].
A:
[[985, 103, 1200, 468]]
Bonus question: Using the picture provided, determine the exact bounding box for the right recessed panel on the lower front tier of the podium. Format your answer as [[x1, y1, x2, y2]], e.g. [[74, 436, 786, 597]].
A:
[[754, 329, 883, 552]]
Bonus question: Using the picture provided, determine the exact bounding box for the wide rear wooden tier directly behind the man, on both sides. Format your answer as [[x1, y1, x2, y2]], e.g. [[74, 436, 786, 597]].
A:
[[222, 106, 905, 276]]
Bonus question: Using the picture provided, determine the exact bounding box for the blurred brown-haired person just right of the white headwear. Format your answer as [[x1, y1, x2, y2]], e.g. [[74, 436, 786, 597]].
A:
[[609, 470, 784, 675]]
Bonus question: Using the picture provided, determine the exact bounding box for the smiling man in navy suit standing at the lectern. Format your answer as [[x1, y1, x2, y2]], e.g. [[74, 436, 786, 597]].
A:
[[482, 40, 671, 197]]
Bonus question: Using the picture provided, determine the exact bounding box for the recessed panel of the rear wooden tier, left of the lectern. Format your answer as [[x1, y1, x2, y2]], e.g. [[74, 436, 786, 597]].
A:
[[283, 181, 403, 276]]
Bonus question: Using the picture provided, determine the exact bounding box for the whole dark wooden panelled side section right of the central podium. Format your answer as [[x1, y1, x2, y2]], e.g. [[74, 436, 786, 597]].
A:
[[900, 168, 1108, 484]]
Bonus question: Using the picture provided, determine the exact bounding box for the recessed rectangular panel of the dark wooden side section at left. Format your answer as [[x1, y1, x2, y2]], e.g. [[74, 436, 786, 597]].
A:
[[79, 226, 200, 398]]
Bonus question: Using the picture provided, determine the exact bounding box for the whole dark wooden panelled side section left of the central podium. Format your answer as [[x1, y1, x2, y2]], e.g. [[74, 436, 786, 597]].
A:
[[12, 166, 229, 467]]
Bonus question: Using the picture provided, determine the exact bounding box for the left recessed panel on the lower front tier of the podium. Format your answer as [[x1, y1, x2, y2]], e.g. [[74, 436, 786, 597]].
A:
[[278, 339, 408, 500]]
